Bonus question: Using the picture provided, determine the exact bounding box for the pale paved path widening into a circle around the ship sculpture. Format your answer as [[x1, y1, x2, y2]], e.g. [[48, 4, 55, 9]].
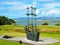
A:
[[0, 36, 59, 45]]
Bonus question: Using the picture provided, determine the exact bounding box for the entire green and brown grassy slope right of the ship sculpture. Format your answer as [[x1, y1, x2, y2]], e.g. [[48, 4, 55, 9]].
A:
[[39, 26, 60, 45]]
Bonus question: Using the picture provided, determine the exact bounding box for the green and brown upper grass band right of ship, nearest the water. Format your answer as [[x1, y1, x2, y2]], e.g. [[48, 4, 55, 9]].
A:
[[38, 26, 60, 32]]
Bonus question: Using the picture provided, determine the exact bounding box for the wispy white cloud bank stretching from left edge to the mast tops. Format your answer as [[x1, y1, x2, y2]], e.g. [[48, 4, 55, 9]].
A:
[[0, 2, 37, 11]]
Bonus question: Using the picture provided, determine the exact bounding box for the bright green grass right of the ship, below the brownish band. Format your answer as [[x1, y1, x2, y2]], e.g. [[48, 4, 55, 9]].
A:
[[40, 32, 60, 45]]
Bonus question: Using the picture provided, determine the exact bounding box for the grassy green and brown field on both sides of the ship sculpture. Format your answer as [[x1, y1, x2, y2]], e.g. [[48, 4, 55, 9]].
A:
[[0, 25, 60, 45]]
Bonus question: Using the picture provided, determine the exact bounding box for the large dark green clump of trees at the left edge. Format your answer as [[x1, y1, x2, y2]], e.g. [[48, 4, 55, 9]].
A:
[[0, 16, 15, 25]]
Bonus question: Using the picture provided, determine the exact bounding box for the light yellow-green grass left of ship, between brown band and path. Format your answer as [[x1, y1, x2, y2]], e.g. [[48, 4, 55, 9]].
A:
[[0, 31, 26, 37]]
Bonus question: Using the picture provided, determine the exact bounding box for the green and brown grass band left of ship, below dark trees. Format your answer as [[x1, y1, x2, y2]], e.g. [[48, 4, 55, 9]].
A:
[[0, 25, 25, 32]]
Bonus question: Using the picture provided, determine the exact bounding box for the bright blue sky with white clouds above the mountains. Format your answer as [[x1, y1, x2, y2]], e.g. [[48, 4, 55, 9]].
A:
[[0, 0, 60, 18]]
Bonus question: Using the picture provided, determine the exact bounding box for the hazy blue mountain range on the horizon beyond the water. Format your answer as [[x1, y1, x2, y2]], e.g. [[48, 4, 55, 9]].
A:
[[14, 17, 60, 21]]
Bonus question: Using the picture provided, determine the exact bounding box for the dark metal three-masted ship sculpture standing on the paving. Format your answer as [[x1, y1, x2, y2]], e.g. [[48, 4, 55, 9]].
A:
[[25, 7, 39, 41]]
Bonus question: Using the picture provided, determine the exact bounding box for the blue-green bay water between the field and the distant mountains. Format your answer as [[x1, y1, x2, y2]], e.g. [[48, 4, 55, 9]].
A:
[[16, 20, 60, 26]]
